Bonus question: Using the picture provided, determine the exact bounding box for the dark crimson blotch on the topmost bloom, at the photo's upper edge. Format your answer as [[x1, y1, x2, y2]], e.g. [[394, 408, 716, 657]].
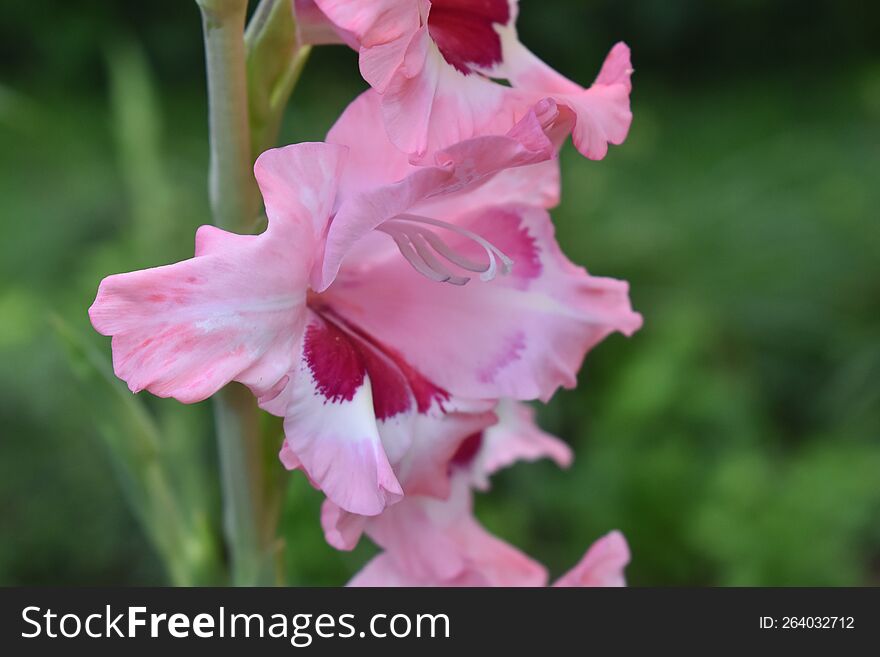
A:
[[428, 0, 510, 75]]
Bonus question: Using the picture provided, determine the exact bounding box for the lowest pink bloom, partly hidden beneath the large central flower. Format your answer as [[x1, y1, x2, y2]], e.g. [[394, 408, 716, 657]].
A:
[[340, 401, 629, 586]]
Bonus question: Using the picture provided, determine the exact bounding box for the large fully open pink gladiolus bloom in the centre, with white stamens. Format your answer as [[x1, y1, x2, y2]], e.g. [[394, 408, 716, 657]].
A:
[[90, 94, 641, 515]]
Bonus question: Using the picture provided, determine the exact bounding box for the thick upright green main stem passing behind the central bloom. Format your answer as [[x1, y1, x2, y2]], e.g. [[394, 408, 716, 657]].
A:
[[197, 0, 276, 586]]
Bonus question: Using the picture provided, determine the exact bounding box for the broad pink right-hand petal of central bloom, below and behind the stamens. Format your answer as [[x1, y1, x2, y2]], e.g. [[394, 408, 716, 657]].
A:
[[327, 205, 641, 399]]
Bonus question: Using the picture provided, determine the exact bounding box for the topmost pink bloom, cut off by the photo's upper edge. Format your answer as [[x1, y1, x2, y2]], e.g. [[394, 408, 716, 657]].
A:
[[295, 0, 632, 160]]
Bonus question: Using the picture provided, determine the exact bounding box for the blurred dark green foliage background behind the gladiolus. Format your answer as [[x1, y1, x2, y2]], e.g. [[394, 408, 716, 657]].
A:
[[0, 0, 880, 585]]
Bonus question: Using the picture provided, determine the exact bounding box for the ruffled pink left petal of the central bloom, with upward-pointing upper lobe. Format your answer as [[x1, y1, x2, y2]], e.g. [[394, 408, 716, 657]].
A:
[[89, 144, 344, 403]]
